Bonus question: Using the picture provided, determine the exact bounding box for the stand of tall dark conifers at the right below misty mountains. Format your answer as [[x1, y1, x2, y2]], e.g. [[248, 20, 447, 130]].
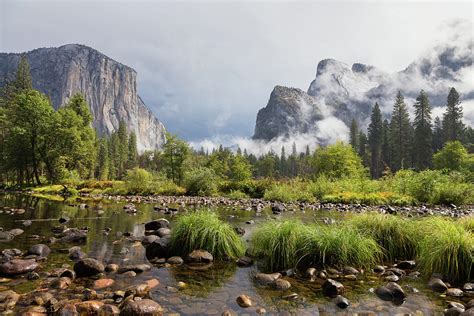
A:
[[349, 88, 474, 178]]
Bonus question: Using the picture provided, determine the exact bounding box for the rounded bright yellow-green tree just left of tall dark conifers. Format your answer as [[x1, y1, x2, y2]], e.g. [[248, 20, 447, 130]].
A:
[[313, 142, 365, 179]]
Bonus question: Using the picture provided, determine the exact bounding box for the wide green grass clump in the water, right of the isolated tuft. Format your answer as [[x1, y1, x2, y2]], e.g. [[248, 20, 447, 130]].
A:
[[252, 220, 381, 271]]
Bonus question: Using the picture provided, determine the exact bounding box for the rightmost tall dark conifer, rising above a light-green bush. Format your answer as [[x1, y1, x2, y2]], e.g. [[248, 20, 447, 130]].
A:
[[443, 88, 465, 143]]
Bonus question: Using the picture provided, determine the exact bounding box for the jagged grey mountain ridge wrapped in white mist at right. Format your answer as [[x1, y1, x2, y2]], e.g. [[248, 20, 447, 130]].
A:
[[253, 41, 474, 143]]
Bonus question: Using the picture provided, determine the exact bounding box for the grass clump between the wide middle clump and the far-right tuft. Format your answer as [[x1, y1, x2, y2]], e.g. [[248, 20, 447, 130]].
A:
[[346, 213, 420, 262]]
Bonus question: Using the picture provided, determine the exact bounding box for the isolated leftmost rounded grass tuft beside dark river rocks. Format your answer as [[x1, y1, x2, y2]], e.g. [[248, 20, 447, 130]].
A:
[[171, 211, 245, 259]]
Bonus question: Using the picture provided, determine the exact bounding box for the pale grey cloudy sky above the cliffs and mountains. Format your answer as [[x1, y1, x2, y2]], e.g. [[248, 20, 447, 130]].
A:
[[0, 0, 473, 141]]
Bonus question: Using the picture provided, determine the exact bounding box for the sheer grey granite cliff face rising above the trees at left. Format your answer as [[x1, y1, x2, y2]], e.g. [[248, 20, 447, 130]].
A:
[[0, 44, 165, 151]]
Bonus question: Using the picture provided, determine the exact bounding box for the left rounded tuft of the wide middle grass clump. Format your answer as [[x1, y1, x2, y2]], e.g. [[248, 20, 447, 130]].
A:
[[251, 220, 307, 271]]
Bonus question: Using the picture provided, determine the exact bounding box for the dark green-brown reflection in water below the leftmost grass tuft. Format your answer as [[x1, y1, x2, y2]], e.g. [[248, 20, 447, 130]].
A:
[[169, 262, 237, 297]]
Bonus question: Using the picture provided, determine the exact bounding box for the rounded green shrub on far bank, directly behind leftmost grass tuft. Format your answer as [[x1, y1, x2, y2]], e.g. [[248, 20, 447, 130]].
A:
[[185, 168, 218, 196]]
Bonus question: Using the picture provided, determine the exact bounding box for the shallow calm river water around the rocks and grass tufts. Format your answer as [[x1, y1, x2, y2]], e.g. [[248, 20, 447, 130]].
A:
[[0, 195, 460, 315]]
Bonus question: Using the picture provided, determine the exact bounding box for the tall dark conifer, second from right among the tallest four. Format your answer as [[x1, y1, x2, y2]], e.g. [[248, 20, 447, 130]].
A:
[[413, 90, 433, 170]]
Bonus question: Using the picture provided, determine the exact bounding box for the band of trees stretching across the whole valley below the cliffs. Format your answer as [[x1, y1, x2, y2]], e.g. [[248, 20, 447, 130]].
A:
[[0, 57, 474, 186]]
